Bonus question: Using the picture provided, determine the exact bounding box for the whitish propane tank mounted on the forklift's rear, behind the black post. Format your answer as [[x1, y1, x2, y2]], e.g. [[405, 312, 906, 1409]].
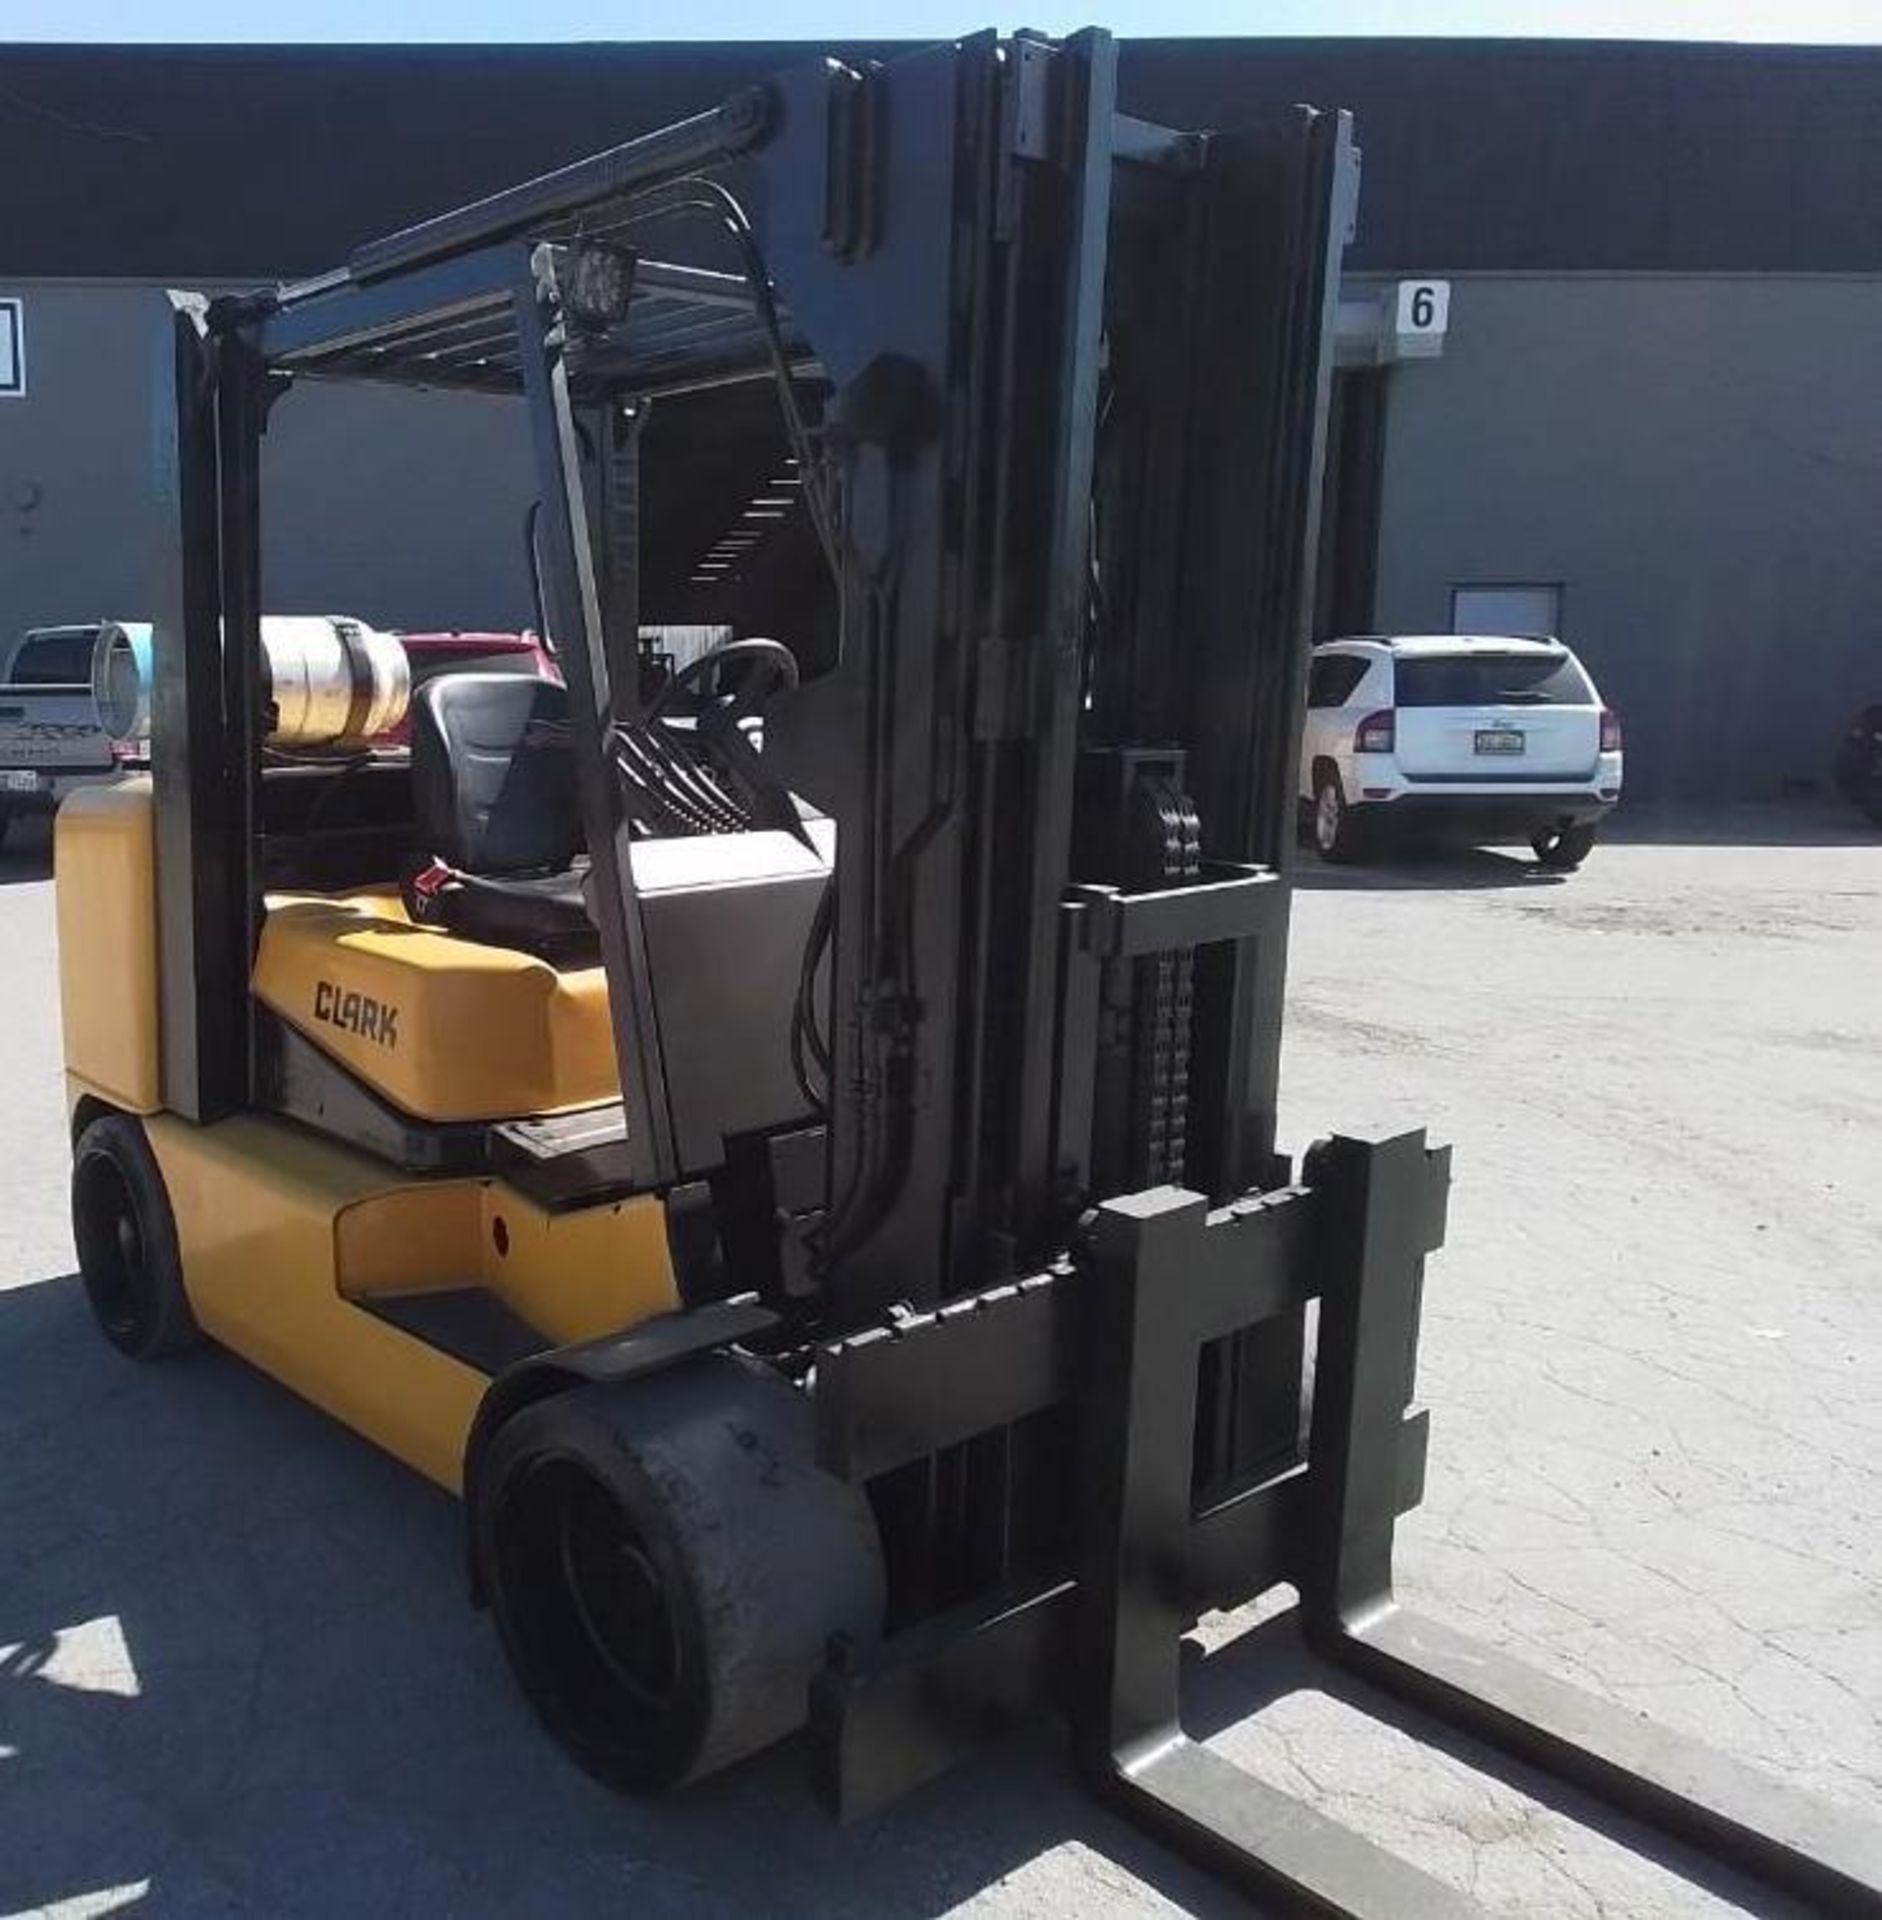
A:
[[92, 614, 411, 751]]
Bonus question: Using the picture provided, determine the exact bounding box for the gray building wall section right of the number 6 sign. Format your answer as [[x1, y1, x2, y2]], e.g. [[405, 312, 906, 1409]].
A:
[[1373, 276, 1882, 799]]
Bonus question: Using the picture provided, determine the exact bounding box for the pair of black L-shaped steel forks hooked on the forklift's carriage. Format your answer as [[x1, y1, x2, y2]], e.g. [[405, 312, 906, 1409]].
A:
[[1075, 1135, 1882, 1916]]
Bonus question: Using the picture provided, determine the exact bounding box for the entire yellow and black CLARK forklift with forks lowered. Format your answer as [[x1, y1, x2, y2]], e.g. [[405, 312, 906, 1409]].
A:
[[58, 33, 1882, 1920]]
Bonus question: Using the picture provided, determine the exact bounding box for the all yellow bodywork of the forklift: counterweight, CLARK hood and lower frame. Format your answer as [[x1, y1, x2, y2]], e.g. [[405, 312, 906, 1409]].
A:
[[56, 780, 680, 1492]]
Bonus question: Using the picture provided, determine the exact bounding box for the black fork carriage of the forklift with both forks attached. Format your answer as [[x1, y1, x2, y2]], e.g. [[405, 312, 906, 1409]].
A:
[[812, 1133, 1882, 1920]]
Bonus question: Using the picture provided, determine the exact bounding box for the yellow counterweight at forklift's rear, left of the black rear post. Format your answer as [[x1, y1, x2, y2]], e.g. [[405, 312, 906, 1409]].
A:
[[52, 778, 163, 1114]]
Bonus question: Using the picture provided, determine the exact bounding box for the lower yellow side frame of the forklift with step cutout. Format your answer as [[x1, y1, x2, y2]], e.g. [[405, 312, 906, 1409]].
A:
[[148, 1116, 678, 1492]]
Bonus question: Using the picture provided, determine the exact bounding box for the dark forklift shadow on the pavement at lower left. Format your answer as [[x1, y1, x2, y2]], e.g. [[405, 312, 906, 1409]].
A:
[[0, 1275, 1246, 1920]]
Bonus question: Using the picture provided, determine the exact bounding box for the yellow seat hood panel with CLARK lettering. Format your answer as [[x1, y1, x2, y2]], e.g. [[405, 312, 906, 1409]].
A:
[[253, 889, 620, 1121]]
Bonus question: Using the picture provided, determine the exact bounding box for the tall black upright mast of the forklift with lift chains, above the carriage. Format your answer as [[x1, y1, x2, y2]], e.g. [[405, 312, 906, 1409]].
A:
[[748, 36, 1356, 1329]]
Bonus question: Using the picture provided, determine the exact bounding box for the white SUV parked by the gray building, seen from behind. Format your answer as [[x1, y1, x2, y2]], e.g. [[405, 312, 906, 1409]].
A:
[[1300, 634, 1621, 870]]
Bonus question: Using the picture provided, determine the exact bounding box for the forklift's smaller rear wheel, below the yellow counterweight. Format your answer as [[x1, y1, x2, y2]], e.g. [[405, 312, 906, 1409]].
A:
[[71, 1114, 202, 1359]]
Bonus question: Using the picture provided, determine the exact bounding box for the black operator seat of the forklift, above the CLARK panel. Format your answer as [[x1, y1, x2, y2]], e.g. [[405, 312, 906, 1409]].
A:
[[403, 674, 599, 962]]
